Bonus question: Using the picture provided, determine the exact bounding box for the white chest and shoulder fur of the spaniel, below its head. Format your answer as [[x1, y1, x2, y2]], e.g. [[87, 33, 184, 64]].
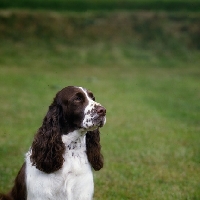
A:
[[26, 131, 94, 200]]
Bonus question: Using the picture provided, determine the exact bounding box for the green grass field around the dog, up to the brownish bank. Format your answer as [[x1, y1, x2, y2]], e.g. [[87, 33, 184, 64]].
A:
[[0, 7, 200, 200]]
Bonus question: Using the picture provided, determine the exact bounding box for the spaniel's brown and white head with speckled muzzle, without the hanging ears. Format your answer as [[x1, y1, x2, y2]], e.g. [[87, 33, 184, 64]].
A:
[[54, 86, 106, 134]]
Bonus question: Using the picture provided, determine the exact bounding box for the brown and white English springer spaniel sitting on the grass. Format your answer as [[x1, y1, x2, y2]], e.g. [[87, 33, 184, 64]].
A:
[[0, 86, 106, 200]]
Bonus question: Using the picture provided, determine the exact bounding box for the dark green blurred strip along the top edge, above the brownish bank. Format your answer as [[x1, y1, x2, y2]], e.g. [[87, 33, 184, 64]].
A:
[[0, 0, 200, 11]]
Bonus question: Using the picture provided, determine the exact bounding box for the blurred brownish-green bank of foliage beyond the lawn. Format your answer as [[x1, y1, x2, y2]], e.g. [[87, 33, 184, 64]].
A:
[[0, 10, 200, 51]]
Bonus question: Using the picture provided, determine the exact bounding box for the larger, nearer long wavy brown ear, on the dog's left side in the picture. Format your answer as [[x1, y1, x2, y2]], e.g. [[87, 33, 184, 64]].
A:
[[31, 98, 65, 173]]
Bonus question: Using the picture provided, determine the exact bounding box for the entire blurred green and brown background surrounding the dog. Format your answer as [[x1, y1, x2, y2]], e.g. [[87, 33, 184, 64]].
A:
[[0, 0, 200, 200]]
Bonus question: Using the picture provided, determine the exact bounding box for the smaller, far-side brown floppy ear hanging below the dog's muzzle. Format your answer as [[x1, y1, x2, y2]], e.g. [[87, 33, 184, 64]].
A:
[[86, 129, 103, 171]]
